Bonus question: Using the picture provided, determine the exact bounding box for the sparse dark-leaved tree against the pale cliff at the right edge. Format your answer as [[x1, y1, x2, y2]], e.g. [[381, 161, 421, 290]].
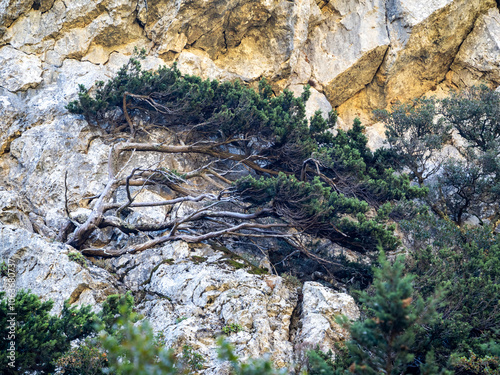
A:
[[376, 86, 500, 227]]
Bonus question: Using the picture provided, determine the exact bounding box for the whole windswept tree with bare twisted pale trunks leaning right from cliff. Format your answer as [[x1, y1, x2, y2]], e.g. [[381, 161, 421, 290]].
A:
[[61, 53, 425, 286]]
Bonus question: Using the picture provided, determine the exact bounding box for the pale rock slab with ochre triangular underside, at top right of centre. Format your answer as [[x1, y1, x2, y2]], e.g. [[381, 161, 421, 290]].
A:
[[304, 0, 390, 107]]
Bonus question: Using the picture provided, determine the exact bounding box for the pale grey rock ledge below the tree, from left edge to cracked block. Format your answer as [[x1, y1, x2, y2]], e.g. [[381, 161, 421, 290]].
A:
[[0, 220, 359, 374]]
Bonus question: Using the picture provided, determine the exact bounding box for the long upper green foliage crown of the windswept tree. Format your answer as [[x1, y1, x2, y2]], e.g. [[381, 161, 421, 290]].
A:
[[67, 50, 320, 173]]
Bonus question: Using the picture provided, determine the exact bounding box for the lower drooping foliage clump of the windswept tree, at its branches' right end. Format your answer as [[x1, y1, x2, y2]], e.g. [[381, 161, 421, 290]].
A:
[[236, 174, 399, 252]]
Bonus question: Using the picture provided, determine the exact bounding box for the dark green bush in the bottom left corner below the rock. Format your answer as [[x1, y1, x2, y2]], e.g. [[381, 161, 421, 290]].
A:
[[0, 290, 146, 374]]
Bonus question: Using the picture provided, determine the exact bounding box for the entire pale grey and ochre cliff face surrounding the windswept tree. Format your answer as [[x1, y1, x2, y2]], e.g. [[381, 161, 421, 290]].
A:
[[0, 0, 500, 374]]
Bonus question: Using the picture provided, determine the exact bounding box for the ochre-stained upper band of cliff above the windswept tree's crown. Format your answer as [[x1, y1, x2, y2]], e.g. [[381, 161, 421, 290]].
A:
[[0, 0, 498, 123]]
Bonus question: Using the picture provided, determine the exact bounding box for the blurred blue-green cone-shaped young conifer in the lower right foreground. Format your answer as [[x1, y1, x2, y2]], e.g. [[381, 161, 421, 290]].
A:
[[341, 252, 435, 375]]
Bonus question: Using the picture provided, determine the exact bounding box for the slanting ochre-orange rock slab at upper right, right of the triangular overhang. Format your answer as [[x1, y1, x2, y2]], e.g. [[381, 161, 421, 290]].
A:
[[339, 0, 496, 123]]
